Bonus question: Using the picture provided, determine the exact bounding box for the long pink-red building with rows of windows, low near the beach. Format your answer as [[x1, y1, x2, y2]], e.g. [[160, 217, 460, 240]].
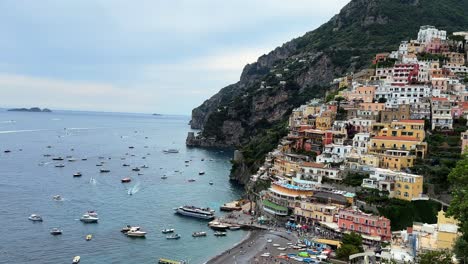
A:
[[338, 208, 392, 241]]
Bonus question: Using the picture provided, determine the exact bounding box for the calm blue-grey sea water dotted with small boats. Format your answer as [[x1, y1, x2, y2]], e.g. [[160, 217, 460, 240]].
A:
[[0, 110, 245, 263]]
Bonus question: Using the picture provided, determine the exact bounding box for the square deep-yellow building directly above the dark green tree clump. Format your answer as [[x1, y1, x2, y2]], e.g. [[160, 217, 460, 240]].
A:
[[393, 173, 423, 201]]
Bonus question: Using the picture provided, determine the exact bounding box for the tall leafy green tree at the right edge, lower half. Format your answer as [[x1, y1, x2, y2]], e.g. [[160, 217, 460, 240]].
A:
[[447, 153, 468, 263]]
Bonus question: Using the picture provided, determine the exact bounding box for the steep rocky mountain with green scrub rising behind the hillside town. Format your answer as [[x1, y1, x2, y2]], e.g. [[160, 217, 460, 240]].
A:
[[187, 0, 468, 183]]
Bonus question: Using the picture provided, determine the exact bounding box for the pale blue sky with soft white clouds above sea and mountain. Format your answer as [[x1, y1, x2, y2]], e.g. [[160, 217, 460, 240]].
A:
[[0, 0, 349, 115]]
